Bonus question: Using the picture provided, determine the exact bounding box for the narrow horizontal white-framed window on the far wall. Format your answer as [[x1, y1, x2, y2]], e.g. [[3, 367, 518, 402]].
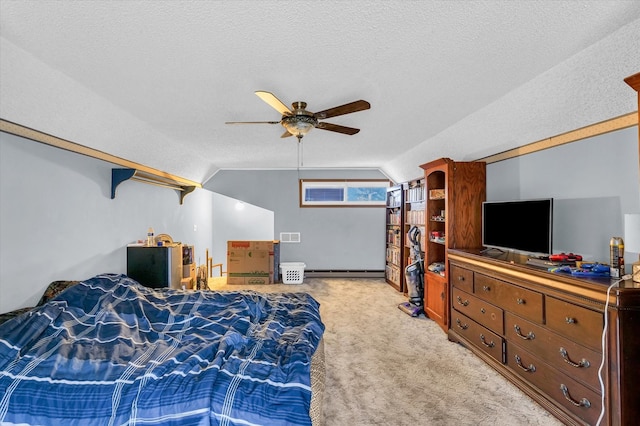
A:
[[300, 179, 391, 207]]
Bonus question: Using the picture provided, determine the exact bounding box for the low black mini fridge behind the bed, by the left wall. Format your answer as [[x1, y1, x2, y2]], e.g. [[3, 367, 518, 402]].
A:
[[127, 244, 182, 288]]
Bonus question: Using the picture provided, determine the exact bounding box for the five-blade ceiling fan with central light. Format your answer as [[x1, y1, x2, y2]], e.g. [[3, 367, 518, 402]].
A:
[[225, 91, 371, 142]]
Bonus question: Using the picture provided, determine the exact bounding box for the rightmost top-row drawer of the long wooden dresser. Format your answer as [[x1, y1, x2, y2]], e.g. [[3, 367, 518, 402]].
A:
[[545, 297, 604, 351]]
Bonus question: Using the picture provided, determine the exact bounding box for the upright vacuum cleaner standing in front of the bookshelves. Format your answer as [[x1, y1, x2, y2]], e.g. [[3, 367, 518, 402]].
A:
[[398, 225, 424, 317]]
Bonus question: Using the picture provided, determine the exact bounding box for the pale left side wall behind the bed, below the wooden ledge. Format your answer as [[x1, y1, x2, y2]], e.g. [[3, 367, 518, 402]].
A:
[[0, 133, 214, 312]]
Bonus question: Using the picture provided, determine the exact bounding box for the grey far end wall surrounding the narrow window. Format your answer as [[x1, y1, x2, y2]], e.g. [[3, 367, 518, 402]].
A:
[[203, 169, 388, 271]]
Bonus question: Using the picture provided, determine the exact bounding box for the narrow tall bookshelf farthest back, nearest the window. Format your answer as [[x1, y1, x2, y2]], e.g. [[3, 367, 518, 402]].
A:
[[385, 185, 404, 291]]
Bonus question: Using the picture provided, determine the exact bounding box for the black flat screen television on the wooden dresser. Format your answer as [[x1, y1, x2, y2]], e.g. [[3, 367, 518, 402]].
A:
[[482, 198, 553, 254]]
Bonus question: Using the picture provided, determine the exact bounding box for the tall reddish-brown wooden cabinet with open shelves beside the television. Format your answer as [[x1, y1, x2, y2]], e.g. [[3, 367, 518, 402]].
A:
[[420, 158, 486, 332]]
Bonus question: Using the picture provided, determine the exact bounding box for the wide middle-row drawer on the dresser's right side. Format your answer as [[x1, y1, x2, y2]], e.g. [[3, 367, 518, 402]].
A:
[[504, 312, 602, 392]]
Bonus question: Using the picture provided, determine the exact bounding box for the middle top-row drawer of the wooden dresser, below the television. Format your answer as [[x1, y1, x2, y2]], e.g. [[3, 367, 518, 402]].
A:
[[473, 274, 543, 324]]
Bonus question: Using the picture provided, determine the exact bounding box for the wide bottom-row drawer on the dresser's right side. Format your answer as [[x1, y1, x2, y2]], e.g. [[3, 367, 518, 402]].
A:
[[506, 341, 602, 424]]
